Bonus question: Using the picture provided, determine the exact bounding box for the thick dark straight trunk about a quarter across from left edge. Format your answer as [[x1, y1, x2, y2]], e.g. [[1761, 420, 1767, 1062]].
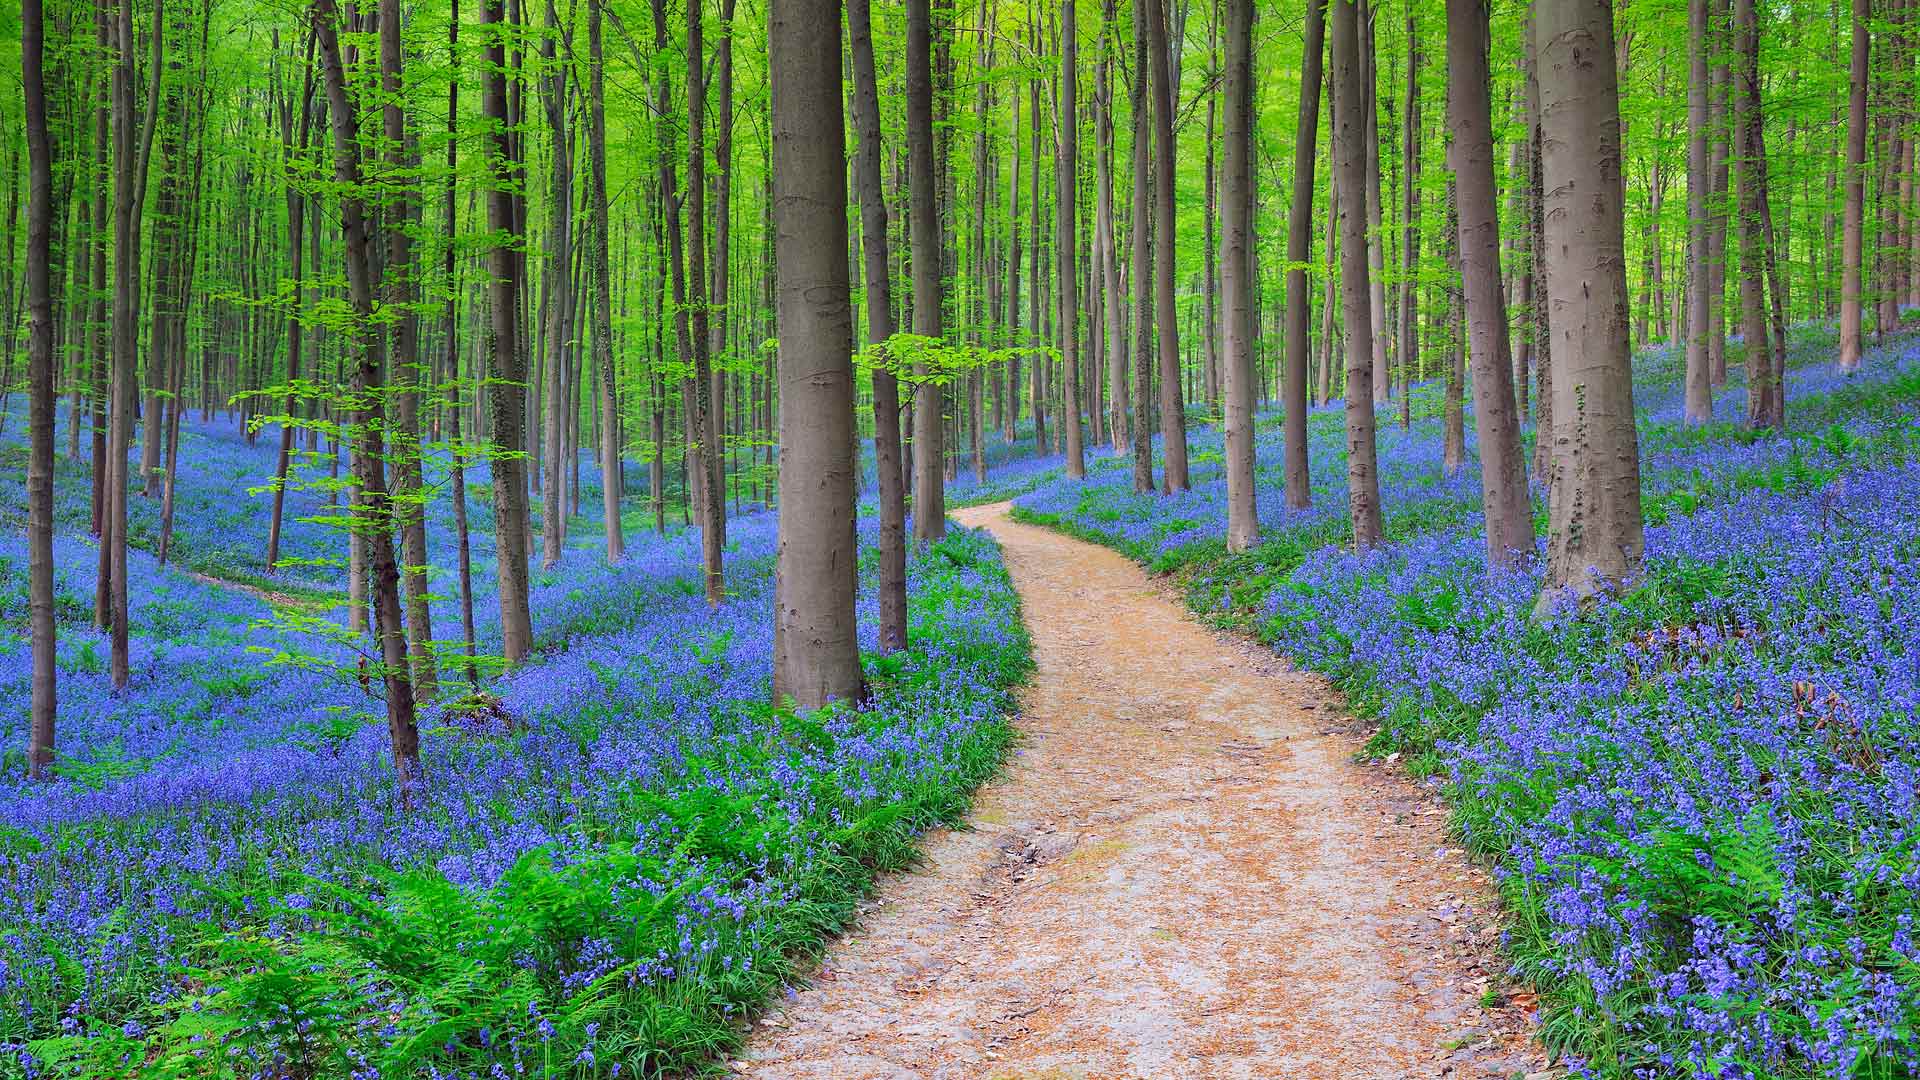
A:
[[480, 0, 534, 663]]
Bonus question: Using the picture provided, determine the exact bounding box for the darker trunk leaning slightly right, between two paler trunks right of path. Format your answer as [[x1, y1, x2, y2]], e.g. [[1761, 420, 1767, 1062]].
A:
[[1281, 0, 1334, 509]]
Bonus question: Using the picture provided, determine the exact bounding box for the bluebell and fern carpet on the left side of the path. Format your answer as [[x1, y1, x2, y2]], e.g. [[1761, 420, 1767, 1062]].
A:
[[0, 407, 1031, 1078]]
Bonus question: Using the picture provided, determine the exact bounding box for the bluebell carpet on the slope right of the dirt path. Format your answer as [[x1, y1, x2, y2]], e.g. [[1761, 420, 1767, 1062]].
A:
[[1016, 325, 1920, 1078]]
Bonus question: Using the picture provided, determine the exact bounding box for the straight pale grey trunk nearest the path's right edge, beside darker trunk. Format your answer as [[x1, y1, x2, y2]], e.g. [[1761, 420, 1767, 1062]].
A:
[[1219, 0, 1260, 552]]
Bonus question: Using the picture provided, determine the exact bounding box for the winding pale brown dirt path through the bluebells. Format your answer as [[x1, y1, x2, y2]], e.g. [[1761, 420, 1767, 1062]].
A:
[[733, 503, 1544, 1080]]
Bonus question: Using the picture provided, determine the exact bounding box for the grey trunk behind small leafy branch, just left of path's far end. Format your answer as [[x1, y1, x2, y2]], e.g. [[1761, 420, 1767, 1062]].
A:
[[910, 0, 948, 540]]
